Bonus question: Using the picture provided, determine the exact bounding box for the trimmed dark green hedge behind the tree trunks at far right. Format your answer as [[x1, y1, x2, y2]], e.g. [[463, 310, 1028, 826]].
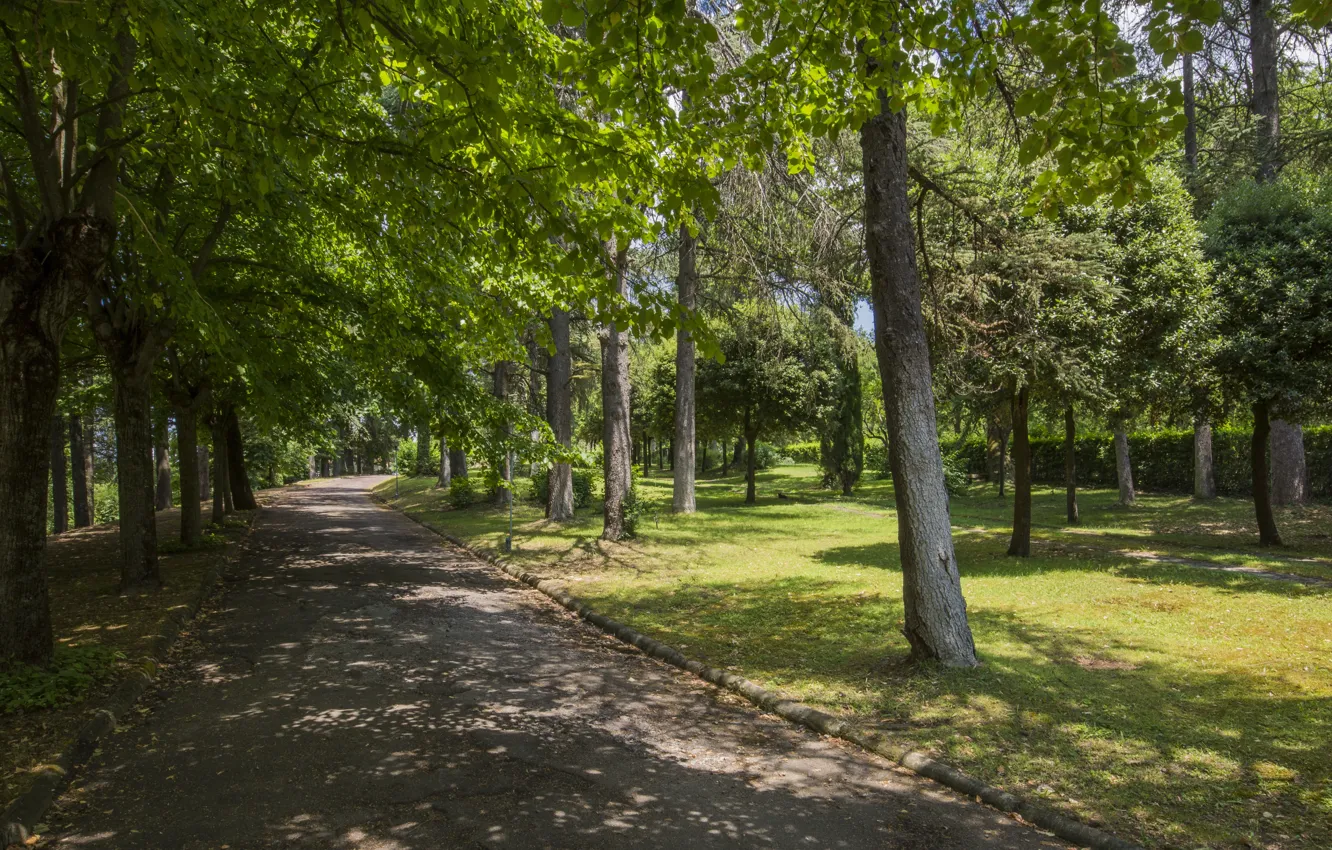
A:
[[954, 425, 1332, 497]]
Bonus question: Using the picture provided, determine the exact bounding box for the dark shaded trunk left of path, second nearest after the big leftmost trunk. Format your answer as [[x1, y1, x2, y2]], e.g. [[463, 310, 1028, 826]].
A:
[[112, 369, 161, 593]]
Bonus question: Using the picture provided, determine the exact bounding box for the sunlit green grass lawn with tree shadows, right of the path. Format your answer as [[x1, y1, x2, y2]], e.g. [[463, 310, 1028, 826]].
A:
[[380, 466, 1332, 849]]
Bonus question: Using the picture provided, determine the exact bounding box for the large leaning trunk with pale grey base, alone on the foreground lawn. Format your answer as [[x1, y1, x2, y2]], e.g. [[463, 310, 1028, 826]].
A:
[[860, 91, 976, 666]]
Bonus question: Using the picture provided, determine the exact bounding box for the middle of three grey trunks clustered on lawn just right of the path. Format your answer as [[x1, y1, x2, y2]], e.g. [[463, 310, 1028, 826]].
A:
[[601, 242, 634, 540]]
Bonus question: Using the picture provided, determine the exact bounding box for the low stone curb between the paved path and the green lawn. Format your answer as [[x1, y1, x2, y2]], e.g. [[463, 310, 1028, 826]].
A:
[[372, 493, 1144, 850]]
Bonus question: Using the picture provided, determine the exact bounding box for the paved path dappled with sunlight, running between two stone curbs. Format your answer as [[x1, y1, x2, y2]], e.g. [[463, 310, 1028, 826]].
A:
[[43, 477, 1064, 850]]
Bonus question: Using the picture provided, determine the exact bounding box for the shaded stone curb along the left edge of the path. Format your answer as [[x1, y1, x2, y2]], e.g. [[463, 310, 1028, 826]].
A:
[[0, 516, 262, 847]]
